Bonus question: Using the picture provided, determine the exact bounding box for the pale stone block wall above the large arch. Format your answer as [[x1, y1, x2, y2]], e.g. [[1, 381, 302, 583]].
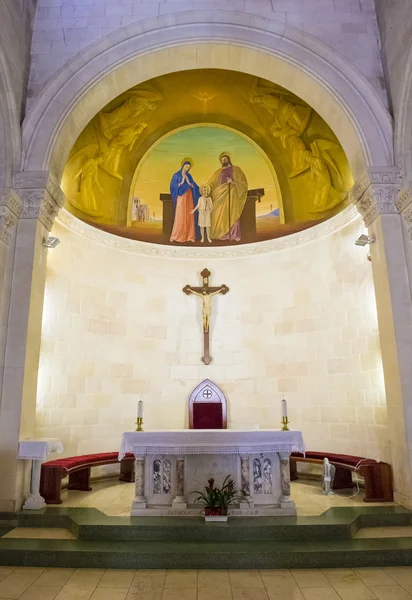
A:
[[30, 0, 386, 101]]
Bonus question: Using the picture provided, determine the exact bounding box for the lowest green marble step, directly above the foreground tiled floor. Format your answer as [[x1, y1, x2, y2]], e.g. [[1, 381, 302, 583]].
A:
[[0, 538, 412, 569]]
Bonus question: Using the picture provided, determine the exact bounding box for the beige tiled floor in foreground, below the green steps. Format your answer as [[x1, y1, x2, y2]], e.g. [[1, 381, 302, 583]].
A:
[[0, 567, 412, 600]]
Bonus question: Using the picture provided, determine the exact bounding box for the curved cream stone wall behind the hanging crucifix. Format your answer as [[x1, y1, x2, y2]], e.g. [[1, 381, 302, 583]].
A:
[[37, 213, 390, 460]]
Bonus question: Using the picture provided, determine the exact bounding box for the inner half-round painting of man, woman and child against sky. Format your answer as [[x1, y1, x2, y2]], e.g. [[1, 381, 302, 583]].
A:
[[129, 125, 288, 245]]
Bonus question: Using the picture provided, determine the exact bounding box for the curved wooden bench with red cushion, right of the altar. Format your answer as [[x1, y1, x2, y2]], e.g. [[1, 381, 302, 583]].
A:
[[290, 452, 393, 502]]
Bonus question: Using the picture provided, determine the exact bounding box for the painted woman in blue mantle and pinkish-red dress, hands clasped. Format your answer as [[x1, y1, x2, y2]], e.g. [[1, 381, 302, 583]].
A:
[[170, 158, 200, 243]]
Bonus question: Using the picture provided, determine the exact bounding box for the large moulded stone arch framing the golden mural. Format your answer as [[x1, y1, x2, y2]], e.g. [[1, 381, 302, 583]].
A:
[[22, 11, 393, 185]]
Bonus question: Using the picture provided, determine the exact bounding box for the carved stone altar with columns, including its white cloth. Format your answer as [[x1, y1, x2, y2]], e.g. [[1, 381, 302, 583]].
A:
[[119, 429, 305, 516]]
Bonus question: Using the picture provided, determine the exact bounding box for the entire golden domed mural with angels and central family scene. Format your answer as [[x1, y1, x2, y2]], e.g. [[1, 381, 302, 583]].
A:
[[62, 70, 353, 245]]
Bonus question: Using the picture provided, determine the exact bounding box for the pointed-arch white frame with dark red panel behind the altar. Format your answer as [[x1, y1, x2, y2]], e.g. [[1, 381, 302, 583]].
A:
[[189, 379, 227, 429]]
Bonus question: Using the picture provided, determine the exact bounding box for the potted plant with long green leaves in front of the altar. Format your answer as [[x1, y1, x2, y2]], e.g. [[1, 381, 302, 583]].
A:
[[191, 475, 249, 521]]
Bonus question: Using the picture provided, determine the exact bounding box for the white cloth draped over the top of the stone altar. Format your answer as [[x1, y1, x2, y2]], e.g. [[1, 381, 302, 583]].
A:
[[119, 429, 306, 460]]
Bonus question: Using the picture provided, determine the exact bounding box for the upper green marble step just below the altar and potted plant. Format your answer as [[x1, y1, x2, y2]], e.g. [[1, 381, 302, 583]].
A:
[[8, 506, 412, 543]]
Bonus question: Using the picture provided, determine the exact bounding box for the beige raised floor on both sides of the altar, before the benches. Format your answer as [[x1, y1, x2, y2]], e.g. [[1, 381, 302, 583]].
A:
[[56, 479, 391, 516]]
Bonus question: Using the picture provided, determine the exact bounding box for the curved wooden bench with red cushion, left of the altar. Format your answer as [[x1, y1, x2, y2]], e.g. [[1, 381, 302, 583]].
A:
[[40, 452, 134, 504]]
